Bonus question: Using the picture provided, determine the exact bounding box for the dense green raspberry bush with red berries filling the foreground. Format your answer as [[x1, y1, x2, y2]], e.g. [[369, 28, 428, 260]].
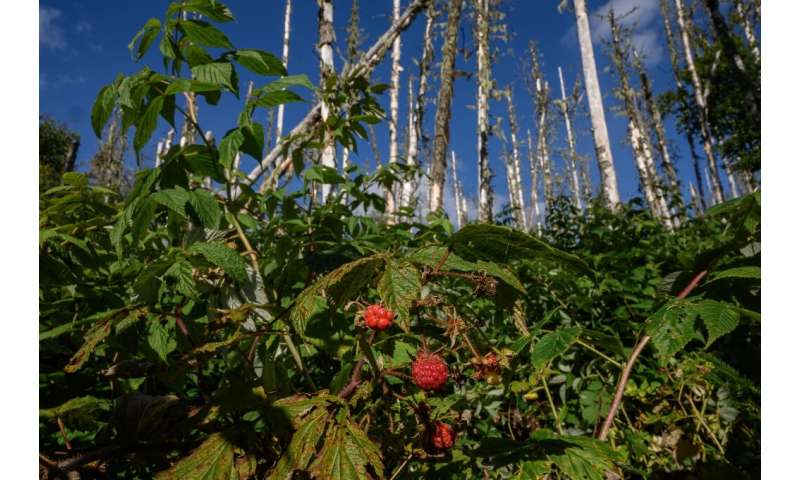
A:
[[39, 0, 760, 480]]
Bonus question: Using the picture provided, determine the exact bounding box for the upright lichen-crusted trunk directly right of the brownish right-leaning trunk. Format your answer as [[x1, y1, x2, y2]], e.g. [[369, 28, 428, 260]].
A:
[[475, 0, 494, 223]]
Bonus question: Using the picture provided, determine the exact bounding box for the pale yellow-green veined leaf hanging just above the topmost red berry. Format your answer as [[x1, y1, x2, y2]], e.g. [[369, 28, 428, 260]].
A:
[[378, 260, 422, 332]]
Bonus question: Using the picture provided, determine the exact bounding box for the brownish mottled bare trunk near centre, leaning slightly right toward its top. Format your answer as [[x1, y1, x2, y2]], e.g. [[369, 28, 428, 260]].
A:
[[428, 0, 464, 212]]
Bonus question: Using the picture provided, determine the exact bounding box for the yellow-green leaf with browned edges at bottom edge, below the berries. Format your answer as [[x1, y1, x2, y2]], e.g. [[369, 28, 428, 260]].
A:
[[309, 420, 384, 480]]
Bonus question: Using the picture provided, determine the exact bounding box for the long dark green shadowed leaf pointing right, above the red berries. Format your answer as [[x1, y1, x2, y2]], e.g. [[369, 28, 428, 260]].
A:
[[451, 224, 589, 272]]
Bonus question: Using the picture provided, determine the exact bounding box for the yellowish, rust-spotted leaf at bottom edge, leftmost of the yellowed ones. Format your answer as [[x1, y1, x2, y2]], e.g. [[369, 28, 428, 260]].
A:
[[154, 433, 234, 480]]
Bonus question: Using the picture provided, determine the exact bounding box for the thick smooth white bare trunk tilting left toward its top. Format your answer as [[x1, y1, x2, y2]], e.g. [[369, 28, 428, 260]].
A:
[[573, 0, 620, 209]]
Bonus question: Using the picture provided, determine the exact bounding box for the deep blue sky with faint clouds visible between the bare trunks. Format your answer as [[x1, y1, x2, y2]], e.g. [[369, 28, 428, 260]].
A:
[[39, 0, 712, 218]]
